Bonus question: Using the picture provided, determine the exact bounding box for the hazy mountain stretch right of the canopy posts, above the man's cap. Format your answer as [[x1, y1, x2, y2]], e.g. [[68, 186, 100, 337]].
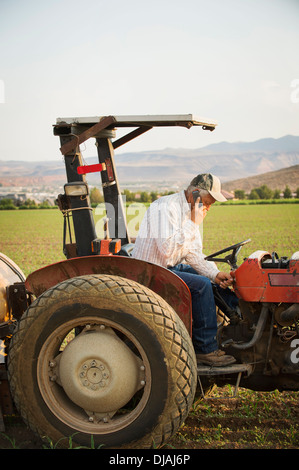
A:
[[116, 136, 299, 182]]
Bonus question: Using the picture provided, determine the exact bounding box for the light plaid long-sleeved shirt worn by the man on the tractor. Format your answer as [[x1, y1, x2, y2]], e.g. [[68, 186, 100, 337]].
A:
[[132, 191, 219, 281]]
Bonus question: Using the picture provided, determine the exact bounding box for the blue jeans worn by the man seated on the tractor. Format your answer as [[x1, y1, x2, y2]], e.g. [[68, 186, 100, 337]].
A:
[[169, 264, 238, 354]]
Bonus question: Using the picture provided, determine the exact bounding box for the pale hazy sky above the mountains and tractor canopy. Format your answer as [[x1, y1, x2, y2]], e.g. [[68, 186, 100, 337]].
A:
[[0, 0, 299, 161]]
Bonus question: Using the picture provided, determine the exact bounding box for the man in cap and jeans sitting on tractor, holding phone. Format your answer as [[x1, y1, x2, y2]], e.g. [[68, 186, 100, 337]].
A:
[[132, 173, 238, 367]]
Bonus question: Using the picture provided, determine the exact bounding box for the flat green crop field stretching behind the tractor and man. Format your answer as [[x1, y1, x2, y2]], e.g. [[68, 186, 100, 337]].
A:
[[0, 204, 299, 275]]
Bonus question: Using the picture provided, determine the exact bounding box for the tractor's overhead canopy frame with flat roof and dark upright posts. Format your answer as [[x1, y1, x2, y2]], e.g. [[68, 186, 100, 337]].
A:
[[54, 114, 217, 253]]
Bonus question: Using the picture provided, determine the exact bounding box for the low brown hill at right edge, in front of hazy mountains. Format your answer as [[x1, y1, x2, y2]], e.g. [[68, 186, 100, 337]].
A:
[[222, 165, 299, 193]]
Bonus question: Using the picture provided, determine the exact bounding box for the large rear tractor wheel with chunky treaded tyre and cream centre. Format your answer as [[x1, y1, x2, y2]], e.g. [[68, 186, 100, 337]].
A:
[[8, 275, 197, 448]]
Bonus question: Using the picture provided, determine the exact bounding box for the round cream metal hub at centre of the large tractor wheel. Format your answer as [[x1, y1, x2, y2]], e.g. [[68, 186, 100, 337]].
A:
[[57, 326, 144, 416]]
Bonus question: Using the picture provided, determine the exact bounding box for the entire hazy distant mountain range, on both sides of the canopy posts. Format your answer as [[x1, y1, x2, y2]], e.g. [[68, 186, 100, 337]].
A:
[[0, 135, 299, 189]]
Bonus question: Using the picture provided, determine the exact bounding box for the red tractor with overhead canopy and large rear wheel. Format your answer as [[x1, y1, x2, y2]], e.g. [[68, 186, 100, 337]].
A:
[[0, 114, 299, 449]]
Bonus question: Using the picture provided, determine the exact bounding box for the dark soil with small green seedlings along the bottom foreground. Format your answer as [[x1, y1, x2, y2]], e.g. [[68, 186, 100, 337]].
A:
[[0, 387, 299, 449]]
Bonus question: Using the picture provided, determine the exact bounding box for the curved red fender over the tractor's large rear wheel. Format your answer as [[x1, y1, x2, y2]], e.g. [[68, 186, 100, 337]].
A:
[[25, 255, 192, 335]]
